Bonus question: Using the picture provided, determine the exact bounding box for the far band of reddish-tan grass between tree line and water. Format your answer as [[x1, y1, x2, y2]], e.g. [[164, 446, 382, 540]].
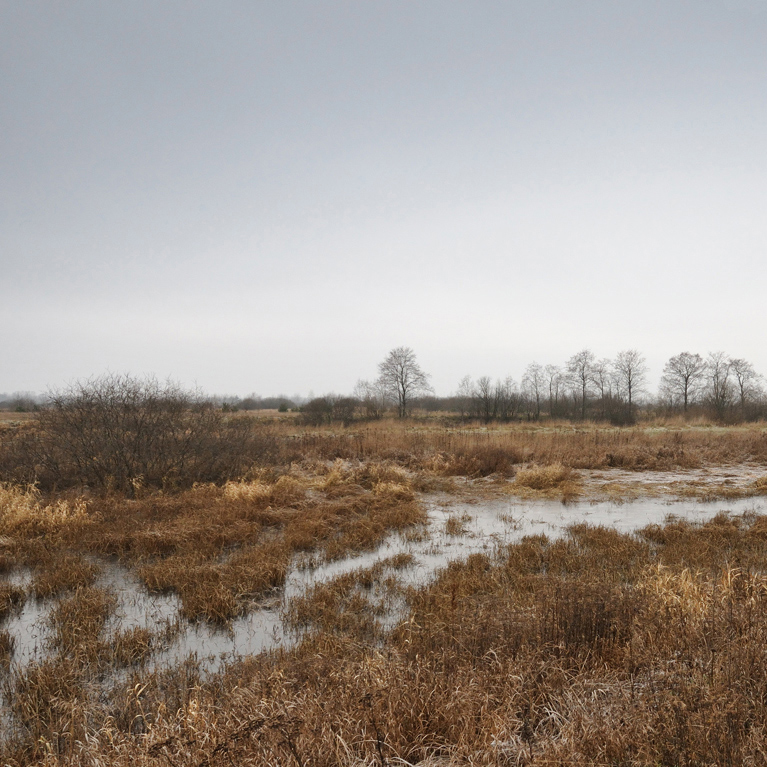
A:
[[274, 421, 767, 476]]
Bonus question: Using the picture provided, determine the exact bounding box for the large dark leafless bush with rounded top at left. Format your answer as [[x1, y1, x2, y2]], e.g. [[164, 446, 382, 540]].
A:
[[1, 375, 276, 492]]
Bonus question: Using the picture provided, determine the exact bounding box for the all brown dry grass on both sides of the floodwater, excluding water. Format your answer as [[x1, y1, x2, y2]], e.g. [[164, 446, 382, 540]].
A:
[[0, 423, 767, 767]]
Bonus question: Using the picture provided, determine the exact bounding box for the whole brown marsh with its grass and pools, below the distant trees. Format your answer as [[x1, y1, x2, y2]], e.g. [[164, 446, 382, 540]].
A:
[[0, 380, 767, 767]]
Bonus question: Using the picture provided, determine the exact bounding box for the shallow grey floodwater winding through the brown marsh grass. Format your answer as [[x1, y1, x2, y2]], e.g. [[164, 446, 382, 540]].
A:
[[3, 497, 767, 671]]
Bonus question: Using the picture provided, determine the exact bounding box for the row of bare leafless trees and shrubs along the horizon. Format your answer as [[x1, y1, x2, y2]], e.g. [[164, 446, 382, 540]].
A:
[[301, 347, 767, 425]]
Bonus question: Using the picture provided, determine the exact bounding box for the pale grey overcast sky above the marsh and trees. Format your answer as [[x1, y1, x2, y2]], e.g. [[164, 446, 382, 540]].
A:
[[0, 0, 767, 396]]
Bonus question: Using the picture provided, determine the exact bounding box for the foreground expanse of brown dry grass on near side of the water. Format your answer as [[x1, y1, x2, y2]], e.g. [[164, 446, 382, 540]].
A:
[[5, 515, 767, 767]]
